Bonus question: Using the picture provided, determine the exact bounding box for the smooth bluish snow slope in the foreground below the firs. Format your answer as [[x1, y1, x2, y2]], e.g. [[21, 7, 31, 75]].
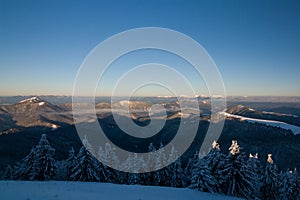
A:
[[0, 181, 237, 200]]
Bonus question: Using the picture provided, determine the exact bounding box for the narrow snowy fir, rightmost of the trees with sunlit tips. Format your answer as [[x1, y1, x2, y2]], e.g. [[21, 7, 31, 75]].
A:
[[261, 154, 280, 199]]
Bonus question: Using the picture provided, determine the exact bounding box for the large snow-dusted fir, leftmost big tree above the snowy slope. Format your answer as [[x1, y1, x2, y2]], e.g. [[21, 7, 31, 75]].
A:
[[15, 134, 56, 181]]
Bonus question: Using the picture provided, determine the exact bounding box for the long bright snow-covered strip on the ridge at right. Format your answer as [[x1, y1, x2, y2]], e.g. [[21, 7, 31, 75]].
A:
[[222, 112, 300, 135]]
